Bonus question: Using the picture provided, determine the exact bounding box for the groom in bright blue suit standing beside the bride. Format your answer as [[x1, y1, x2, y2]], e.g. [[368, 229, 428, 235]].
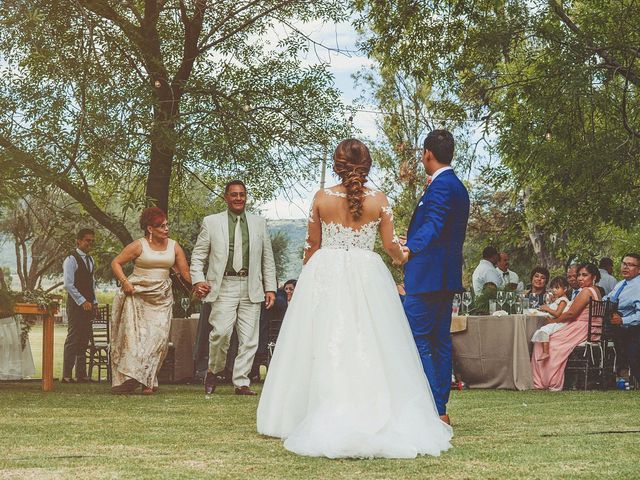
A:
[[404, 130, 469, 423]]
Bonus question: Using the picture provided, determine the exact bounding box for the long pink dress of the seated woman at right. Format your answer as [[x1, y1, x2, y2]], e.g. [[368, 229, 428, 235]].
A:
[[531, 287, 602, 391]]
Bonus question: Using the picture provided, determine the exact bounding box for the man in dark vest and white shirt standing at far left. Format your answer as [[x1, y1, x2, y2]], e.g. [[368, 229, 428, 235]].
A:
[[62, 228, 97, 383]]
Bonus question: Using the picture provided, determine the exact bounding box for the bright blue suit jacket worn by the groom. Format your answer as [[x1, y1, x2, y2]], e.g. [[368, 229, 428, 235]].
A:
[[404, 170, 469, 295]]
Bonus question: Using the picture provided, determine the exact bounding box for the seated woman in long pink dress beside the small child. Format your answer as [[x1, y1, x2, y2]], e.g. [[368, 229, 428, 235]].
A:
[[531, 263, 602, 391]]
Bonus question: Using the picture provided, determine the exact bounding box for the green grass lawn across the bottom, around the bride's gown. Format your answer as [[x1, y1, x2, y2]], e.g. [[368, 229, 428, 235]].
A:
[[0, 329, 640, 479]]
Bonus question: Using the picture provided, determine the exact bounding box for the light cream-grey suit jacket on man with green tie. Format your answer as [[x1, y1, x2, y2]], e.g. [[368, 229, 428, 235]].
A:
[[190, 210, 277, 303]]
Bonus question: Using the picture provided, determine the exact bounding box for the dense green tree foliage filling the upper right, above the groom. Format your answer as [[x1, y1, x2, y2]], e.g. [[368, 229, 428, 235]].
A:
[[355, 0, 640, 268]]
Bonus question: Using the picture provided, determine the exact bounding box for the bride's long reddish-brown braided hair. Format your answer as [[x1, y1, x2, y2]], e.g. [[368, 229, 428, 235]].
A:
[[333, 138, 371, 220]]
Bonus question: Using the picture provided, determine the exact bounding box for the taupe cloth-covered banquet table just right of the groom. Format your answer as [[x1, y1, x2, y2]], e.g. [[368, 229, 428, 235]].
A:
[[451, 315, 545, 390]]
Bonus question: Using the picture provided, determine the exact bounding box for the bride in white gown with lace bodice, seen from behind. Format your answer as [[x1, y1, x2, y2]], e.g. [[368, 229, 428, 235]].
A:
[[257, 139, 452, 458]]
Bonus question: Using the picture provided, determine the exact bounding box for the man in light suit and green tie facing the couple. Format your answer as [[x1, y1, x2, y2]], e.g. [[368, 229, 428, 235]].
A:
[[191, 180, 277, 395]]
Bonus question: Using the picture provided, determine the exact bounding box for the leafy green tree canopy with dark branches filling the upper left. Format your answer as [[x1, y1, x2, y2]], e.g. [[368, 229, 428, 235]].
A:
[[0, 0, 347, 244]]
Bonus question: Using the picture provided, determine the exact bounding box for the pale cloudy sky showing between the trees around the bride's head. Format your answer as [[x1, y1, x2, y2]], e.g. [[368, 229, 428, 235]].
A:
[[260, 22, 377, 219]]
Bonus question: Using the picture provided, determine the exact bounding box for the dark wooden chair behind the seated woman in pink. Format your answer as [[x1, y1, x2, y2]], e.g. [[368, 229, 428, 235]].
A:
[[565, 298, 618, 390]]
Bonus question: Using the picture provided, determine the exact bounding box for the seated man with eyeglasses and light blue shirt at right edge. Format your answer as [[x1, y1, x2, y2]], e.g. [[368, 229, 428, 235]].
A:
[[605, 253, 640, 381]]
